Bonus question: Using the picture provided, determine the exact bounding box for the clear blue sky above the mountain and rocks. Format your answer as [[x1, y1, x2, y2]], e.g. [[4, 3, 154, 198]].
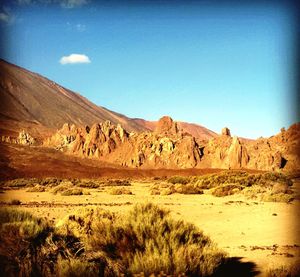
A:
[[0, 0, 299, 138]]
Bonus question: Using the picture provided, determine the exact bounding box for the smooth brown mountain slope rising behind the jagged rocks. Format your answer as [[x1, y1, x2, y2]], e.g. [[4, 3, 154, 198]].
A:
[[0, 60, 216, 139]]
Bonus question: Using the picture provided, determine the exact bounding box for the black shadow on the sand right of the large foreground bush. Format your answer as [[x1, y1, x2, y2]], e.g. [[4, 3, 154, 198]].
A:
[[213, 257, 260, 277]]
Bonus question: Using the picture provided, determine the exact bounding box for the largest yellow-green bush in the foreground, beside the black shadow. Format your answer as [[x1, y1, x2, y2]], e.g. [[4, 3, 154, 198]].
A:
[[57, 204, 226, 276]]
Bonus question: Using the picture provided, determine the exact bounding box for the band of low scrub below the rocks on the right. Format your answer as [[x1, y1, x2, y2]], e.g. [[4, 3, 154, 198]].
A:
[[150, 171, 294, 203]]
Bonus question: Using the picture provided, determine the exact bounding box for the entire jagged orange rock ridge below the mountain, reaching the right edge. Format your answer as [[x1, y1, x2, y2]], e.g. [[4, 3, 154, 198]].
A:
[[44, 117, 300, 170]]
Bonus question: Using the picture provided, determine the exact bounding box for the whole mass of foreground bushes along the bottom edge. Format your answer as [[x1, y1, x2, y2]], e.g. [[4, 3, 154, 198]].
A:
[[0, 204, 226, 276]]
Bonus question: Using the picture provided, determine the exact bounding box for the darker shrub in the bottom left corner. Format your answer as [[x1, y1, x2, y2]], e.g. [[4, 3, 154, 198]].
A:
[[0, 208, 82, 276]]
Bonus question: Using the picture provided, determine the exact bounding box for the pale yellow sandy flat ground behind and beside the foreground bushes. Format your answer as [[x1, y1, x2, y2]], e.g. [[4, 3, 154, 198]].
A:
[[0, 182, 300, 276]]
